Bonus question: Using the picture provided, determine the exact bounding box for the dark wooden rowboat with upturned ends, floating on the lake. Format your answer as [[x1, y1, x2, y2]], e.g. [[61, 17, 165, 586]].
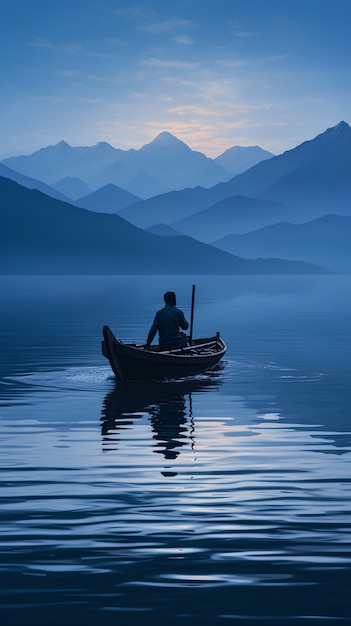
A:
[[102, 326, 227, 381]]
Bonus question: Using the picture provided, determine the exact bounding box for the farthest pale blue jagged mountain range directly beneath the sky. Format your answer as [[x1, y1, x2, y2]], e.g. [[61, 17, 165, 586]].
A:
[[3, 132, 273, 200]]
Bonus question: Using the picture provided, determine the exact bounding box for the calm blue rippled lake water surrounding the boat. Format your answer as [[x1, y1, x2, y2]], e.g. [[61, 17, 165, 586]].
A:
[[0, 276, 351, 626]]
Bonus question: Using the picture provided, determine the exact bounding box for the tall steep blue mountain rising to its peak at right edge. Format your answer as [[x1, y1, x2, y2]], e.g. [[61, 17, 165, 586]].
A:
[[212, 122, 351, 217]]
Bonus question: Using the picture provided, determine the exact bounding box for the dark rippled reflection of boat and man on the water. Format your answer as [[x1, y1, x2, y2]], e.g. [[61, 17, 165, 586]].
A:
[[101, 372, 220, 459]]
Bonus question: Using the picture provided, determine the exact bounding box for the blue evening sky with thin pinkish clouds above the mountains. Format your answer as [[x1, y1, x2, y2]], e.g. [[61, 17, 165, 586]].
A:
[[0, 0, 351, 158]]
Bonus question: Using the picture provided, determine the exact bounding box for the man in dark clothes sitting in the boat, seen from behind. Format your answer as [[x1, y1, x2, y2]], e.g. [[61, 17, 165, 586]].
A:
[[145, 291, 189, 350]]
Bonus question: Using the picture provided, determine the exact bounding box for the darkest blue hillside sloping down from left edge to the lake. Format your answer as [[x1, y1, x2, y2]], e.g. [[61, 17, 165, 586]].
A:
[[0, 177, 323, 274]]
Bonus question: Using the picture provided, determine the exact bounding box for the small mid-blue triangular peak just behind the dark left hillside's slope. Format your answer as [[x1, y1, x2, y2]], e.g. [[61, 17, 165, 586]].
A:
[[74, 184, 140, 213]]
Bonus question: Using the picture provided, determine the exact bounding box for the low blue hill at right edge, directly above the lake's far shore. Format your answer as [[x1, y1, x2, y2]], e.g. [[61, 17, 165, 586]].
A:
[[212, 215, 351, 273]]
